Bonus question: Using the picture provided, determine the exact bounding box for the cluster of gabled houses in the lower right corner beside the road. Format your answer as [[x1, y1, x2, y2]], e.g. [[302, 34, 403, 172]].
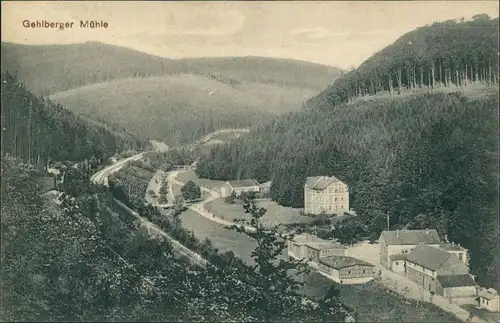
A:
[[379, 229, 500, 311]]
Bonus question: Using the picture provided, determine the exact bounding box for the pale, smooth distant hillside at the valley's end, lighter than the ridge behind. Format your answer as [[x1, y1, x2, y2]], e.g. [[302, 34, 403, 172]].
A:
[[50, 74, 316, 144]]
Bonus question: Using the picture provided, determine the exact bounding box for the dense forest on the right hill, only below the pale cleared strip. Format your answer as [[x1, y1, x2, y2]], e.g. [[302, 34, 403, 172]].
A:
[[197, 89, 499, 292]]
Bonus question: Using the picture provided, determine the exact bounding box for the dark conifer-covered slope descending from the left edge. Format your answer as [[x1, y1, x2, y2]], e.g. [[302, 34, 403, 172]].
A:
[[1, 73, 142, 167]]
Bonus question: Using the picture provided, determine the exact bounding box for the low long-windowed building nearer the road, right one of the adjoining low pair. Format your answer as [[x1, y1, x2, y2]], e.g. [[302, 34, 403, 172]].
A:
[[318, 256, 375, 284]]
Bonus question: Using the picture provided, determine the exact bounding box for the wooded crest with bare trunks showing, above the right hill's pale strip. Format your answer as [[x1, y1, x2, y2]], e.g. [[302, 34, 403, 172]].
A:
[[307, 14, 499, 107]]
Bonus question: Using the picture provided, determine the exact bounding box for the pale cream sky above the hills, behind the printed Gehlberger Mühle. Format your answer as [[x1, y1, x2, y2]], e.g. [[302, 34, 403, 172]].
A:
[[2, 1, 499, 68]]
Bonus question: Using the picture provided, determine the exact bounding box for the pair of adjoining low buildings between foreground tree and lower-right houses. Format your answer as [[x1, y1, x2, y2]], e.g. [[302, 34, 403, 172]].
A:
[[287, 233, 375, 284]]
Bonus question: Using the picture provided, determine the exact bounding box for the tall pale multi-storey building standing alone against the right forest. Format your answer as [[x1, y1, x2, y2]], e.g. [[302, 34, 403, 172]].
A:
[[304, 176, 349, 215]]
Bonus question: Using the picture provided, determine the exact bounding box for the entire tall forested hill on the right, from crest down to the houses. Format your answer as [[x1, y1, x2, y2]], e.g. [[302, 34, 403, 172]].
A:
[[197, 15, 499, 287]]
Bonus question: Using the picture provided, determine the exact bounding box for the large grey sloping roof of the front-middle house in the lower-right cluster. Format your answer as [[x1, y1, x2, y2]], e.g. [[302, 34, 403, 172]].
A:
[[406, 244, 469, 275]]
